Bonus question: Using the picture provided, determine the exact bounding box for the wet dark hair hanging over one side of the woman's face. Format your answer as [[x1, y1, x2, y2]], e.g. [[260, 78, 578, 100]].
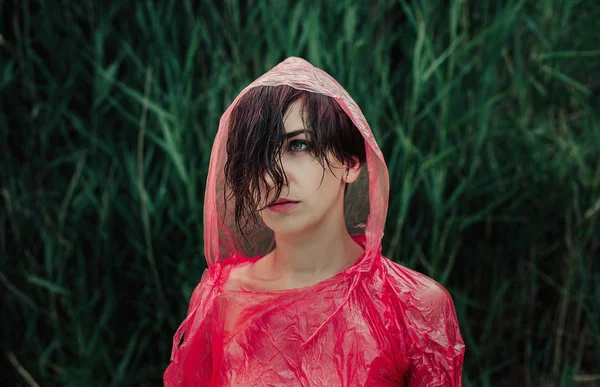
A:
[[225, 85, 366, 235]]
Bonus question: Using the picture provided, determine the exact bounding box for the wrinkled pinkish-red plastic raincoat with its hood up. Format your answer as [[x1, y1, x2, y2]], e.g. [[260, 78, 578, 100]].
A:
[[164, 58, 465, 387]]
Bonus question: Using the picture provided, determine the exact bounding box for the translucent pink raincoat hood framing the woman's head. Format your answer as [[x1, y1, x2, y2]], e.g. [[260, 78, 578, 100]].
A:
[[204, 57, 389, 268]]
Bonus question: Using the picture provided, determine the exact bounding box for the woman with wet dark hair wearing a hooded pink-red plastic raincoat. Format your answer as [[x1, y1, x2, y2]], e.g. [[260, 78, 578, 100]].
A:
[[164, 58, 464, 387]]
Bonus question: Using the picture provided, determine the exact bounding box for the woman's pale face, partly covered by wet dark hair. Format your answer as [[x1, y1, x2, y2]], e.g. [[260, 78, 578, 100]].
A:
[[260, 100, 358, 234]]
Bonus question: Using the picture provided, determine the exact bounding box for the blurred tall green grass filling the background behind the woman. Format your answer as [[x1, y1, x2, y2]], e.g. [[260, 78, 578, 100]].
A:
[[0, 0, 600, 386]]
